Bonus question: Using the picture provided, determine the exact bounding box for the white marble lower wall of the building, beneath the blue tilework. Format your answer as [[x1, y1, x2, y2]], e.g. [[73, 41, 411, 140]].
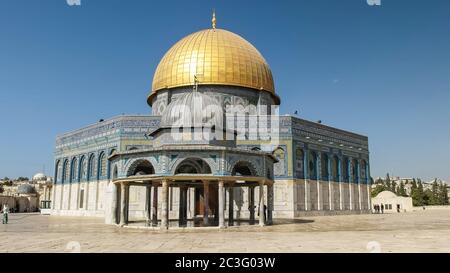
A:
[[52, 179, 369, 220]]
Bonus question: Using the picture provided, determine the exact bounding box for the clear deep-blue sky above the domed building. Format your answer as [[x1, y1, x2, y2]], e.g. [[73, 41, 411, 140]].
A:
[[0, 0, 450, 179]]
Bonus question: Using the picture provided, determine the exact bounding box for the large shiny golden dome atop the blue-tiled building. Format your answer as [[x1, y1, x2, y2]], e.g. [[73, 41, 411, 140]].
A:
[[148, 28, 278, 104]]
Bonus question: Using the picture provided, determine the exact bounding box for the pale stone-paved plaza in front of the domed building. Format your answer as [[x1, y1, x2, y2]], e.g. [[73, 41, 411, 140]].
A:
[[0, 210, 450, 252]]
